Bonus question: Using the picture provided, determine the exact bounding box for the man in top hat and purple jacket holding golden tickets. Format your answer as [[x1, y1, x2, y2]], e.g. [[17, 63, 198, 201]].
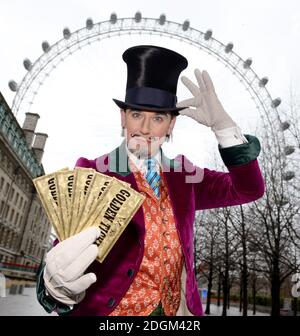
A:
[[37, 45, 264, 316]]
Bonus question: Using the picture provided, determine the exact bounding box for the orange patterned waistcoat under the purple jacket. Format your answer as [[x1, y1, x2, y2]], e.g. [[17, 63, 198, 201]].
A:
[[110, 163, 183, 316]]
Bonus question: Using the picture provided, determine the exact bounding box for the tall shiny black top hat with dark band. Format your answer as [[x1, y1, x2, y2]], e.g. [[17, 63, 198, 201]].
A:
[[113, 45, 188, 115]]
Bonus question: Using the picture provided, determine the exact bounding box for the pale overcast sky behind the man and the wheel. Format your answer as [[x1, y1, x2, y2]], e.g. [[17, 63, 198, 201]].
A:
[[0, 0, 300, 173]]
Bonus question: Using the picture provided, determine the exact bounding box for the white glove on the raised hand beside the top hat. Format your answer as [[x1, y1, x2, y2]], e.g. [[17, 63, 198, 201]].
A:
[[176, 69, 237, 131]]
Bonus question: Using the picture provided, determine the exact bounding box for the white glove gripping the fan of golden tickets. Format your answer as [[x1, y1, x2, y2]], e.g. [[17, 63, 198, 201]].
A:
[[44, 226, 100, 305]]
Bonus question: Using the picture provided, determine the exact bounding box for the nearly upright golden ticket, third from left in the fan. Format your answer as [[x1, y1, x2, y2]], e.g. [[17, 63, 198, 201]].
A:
[[69, 168, 96, 236]]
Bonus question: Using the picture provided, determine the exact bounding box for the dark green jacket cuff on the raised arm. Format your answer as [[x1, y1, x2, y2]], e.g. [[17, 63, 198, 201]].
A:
[[218, 134, 261, 167]]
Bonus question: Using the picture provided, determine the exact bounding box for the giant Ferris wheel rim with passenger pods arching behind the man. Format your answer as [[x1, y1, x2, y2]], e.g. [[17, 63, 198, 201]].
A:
[[9, 12, 291, 178]]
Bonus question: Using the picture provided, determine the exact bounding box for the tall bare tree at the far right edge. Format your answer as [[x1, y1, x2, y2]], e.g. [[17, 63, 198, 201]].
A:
[[250, 98, 300, 316]]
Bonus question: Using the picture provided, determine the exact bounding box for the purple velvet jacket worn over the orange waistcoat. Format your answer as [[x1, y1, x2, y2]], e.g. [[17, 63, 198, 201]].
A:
[[67, 136, 264, 316]]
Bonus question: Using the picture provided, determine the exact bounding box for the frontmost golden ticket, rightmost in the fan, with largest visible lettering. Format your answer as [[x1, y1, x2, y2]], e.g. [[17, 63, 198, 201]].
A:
[[94, 180, 145, 262]]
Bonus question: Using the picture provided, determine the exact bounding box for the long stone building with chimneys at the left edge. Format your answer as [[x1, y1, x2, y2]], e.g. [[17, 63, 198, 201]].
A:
[[0, 93, 53, 279]]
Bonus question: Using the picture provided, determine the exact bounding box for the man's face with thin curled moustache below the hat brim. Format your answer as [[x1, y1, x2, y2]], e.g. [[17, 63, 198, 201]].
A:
[[121, 109, 176, 158]]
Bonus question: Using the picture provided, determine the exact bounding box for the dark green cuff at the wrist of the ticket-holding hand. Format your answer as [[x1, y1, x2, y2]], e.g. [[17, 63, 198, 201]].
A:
[[36, 265, 73, 315]]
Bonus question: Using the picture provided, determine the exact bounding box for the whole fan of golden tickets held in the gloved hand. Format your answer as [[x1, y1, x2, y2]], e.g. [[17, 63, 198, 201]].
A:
[[33, 168, 145, 262]]
